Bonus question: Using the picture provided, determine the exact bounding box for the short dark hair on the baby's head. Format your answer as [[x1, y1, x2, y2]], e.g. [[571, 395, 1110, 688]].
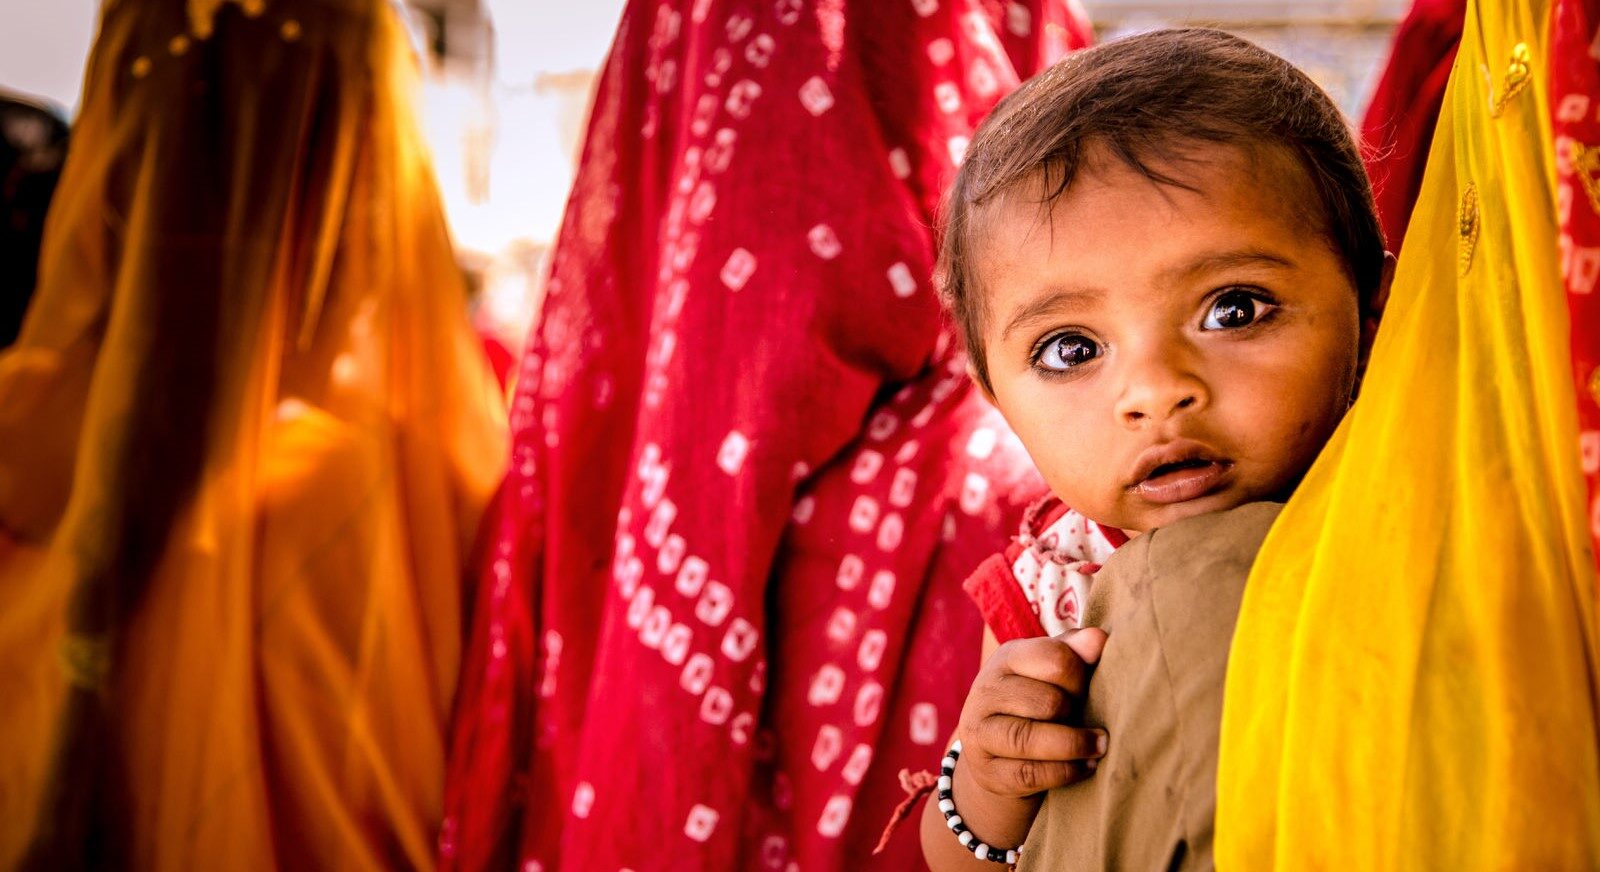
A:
[[938, 29, 1384, 389]]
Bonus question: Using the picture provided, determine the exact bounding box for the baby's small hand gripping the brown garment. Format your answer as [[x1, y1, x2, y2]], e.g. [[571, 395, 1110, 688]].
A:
[[957, 629, 1106, 797]]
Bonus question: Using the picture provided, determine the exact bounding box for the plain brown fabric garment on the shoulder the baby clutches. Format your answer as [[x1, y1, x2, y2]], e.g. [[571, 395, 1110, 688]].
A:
[[1019, 502, 1282, 872]]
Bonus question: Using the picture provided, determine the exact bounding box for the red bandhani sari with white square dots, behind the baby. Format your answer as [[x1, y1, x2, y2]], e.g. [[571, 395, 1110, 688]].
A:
[[440, 0, 1088, 870]]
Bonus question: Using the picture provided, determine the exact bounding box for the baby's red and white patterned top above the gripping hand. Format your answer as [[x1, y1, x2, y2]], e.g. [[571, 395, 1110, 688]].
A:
[[963, 498, 1128, 642]]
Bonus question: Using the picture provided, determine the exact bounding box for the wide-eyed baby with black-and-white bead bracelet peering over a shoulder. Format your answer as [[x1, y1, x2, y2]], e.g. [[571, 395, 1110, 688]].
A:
[[922, 30, 1392, 870]]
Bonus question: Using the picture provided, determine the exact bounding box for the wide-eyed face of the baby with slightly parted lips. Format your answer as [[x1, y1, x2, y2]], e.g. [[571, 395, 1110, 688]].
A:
[[979, 146, 1362, 533]]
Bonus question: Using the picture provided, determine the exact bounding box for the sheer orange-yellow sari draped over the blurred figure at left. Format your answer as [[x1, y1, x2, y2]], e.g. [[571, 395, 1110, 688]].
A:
[[0, 0, 506, 869]]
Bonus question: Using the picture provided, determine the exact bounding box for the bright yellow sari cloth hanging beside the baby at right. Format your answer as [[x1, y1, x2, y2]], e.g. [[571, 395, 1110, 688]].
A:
[[1216, 0, 1600, 869]]
